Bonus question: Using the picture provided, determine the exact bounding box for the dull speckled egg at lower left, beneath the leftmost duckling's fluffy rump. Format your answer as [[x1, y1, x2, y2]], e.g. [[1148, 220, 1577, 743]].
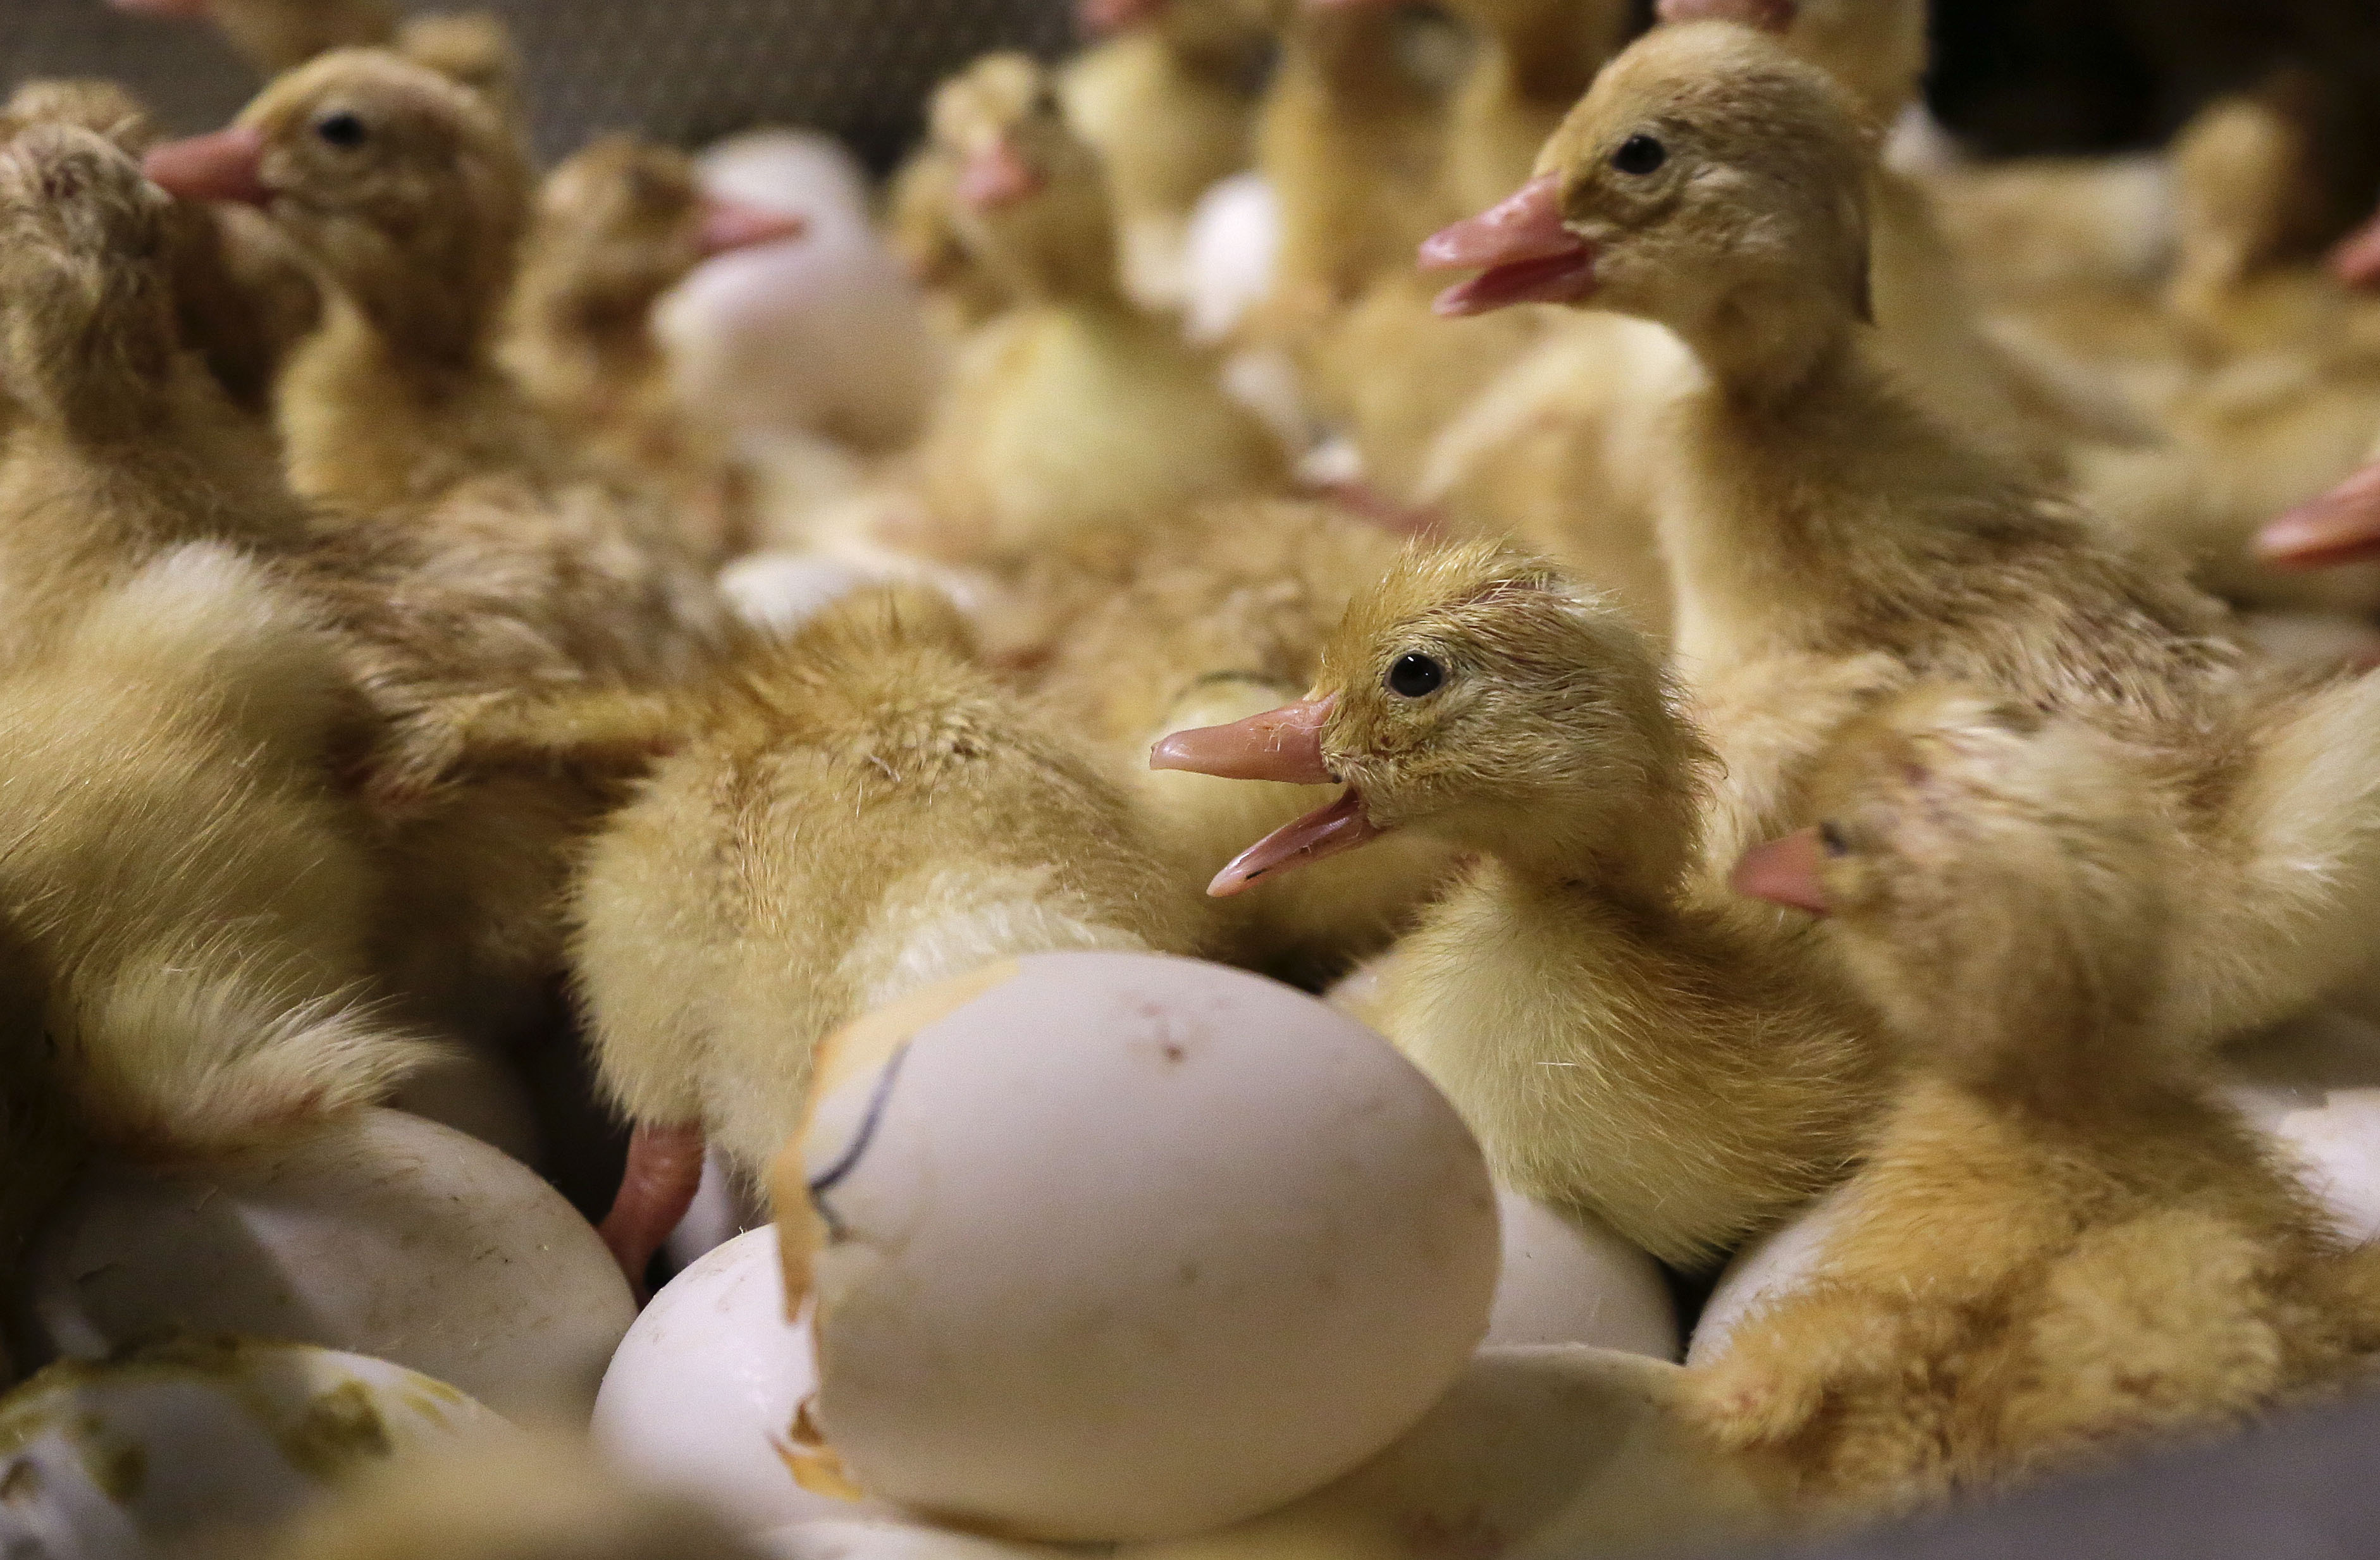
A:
[[19, 1110, 636, 1420]]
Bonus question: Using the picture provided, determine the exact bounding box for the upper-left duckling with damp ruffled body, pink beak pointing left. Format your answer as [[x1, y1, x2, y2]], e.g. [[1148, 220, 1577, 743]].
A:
[[147, 50, 724, 1035]]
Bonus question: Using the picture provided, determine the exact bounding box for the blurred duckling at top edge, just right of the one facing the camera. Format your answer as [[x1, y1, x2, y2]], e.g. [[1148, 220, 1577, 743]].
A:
[[1059, 0, 1273, 309]]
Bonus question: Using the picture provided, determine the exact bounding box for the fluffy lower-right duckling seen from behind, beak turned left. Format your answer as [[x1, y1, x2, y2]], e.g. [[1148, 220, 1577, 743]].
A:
[[1690, 685, 2380, 1508]]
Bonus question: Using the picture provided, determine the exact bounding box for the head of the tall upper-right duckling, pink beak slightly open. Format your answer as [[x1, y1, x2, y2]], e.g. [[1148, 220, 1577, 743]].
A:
[[1421, 21, 1873, 347]]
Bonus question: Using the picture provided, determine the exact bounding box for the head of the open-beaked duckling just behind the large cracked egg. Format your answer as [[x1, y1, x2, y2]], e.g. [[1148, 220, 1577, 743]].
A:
[[1150, 544, 1709, 899]]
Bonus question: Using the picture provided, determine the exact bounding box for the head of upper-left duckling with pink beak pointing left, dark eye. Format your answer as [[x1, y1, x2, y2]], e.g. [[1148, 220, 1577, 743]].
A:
[[147, 50, 531, 359]]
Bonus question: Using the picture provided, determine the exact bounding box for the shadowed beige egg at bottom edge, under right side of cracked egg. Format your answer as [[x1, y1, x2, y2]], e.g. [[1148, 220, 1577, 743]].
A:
[[1119, 1348, 1790, 1560]]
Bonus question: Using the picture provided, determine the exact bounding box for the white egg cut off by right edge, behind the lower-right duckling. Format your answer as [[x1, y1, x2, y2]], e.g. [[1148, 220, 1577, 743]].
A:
[[2223, 1013, 2380, 1244]]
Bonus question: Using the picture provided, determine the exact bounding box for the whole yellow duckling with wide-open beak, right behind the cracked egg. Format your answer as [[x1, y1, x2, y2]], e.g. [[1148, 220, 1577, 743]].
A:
[[1152, 544, 1878, 1267]]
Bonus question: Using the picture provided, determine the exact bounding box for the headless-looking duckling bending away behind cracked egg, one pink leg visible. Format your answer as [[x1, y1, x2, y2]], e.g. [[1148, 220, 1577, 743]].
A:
[[550, 592, 1200, 1277]]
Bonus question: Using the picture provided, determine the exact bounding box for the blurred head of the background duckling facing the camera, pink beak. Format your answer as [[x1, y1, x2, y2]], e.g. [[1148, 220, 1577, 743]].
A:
[[933, 54, 1116, 300]]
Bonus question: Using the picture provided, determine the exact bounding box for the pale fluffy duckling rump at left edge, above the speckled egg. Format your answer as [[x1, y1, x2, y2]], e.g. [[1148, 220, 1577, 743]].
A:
[[0, 542, 424, 1158]]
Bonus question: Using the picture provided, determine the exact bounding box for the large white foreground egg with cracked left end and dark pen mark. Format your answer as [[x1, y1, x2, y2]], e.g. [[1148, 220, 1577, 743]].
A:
[[799, 954, 1497, 1539]]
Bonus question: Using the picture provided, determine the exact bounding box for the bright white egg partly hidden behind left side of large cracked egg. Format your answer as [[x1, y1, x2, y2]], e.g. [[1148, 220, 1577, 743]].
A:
[[593, 1227, 895, 1532]]
